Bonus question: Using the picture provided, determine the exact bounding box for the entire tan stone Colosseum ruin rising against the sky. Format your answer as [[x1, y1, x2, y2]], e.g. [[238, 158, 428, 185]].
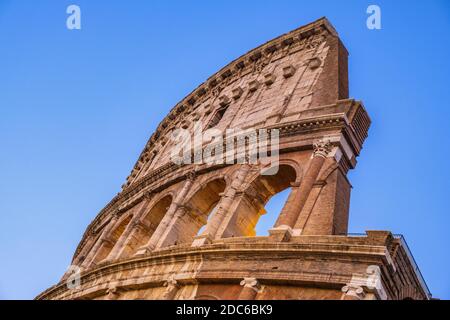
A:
[[38, 19, 430, 300]]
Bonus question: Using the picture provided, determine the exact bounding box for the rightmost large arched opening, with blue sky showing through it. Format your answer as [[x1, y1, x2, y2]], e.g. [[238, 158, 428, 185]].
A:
[[222, 165, 297, 238]]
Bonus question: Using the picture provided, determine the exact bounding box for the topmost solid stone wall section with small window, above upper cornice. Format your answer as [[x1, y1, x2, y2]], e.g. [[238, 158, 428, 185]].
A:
[[123, 18, 348, 189]]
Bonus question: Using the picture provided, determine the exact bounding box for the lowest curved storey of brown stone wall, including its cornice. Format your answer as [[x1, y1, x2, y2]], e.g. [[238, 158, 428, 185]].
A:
[[38, 232, 428, 300]]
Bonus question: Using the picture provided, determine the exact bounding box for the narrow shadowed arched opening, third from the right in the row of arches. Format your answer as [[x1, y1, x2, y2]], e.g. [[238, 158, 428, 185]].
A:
[[120, 195, 172, 258]]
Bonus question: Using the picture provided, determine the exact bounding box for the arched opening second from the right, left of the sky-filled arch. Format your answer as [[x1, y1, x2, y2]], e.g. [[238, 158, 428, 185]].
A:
[[171, 178, 226, 245]]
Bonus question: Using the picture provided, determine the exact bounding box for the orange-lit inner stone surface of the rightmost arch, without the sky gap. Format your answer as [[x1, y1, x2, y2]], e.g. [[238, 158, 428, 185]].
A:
[[222, 162, 298, 238]]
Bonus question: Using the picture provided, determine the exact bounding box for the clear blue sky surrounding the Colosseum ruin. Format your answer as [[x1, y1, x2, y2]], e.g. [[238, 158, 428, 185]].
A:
[[0, 0, 450, 299]]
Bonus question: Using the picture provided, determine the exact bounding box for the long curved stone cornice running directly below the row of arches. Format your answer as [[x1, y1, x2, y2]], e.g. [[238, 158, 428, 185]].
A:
[[36, 236, 394, 300]]
